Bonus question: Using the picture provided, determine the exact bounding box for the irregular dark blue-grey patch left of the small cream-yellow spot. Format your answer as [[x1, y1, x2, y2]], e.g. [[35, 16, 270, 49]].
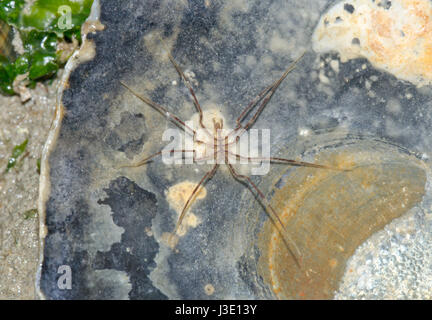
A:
[[94, 177, 166, 299]]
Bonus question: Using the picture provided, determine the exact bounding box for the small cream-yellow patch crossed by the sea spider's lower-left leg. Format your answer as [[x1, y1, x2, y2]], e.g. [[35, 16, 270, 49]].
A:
[[166, 181, 207, 236]]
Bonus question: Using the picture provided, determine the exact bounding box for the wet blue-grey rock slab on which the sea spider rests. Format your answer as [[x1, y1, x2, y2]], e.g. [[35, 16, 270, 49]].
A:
[[40, 0, 432, 299]]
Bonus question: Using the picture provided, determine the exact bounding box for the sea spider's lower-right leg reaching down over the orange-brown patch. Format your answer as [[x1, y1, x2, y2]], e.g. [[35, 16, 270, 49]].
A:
[[227, 163, 301, 268]]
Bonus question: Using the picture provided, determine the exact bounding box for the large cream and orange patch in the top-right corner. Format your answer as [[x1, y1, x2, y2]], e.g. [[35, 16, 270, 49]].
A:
[[313, 0, 432, 86]]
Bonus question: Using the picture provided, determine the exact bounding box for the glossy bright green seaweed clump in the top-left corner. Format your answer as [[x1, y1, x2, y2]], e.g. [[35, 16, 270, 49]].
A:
[[0, 0, 93, 95]]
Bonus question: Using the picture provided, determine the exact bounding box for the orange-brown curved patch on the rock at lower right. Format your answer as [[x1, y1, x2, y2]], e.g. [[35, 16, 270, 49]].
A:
[[258, 149, 426, 299]]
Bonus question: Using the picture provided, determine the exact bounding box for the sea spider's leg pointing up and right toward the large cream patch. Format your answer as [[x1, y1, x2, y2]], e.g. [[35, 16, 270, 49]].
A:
[[228, 52, 306, 140]]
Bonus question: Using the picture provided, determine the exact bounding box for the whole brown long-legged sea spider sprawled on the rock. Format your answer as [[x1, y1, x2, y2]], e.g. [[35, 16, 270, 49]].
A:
[[120, 46, 340, 266]]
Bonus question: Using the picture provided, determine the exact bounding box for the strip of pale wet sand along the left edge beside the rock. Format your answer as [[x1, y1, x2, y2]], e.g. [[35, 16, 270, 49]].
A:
[[0, 80, 58, 299]]
